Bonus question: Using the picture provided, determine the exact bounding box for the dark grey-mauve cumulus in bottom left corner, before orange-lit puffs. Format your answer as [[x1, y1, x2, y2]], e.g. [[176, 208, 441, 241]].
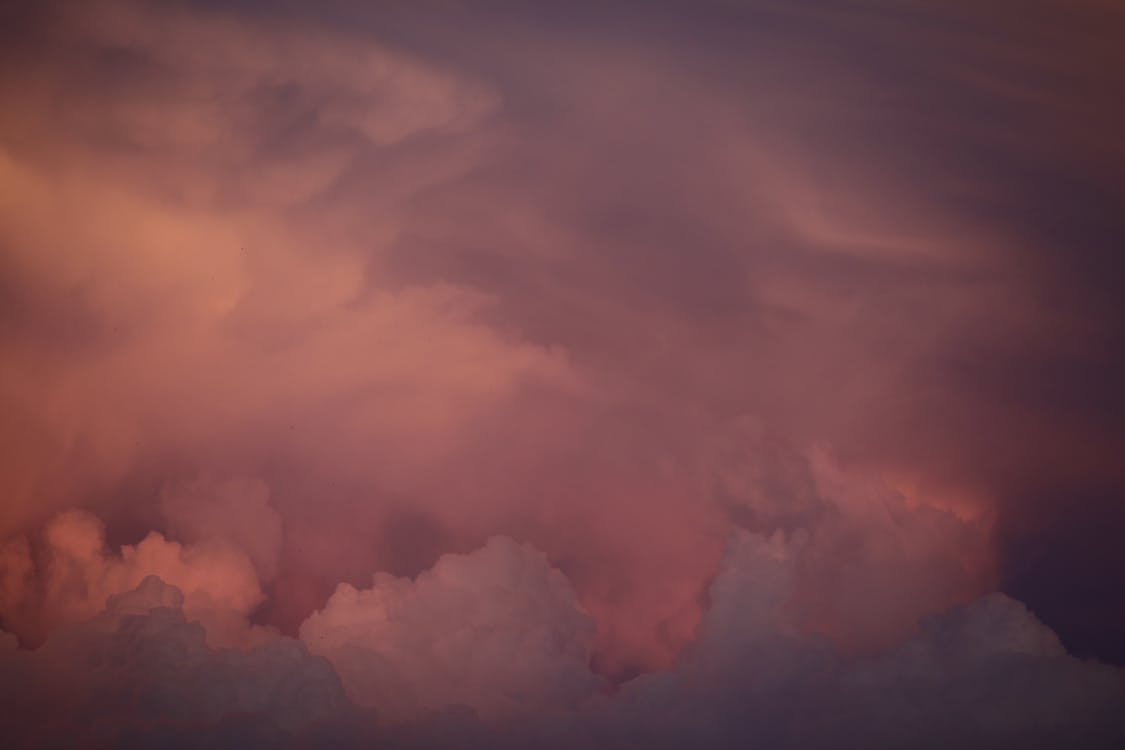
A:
[[0, 576, 352, 748]]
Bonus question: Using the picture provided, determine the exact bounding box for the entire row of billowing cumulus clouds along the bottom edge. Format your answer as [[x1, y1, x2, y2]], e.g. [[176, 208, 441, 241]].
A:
[[0, 531, 1125, 750]]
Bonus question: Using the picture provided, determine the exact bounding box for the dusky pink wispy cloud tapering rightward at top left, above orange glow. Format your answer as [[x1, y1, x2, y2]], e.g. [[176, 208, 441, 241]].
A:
[[6, 0, 498, 202]]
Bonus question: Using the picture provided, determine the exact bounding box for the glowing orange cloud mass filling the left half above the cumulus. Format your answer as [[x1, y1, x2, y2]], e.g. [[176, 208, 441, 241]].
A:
[[0, 2, 584, 661]]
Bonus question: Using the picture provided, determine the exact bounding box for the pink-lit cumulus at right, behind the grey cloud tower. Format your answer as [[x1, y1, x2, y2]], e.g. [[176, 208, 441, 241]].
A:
[[709, 418, 993, 650]]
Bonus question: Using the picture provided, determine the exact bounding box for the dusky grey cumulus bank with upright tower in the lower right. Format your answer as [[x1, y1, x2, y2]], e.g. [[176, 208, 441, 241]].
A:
[[590, 531, 1125, 748]]
